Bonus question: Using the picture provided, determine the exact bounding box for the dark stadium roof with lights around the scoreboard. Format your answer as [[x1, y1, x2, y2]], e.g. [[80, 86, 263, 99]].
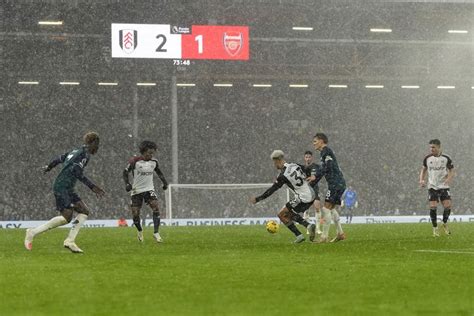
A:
[[0, 0, 474, 84]]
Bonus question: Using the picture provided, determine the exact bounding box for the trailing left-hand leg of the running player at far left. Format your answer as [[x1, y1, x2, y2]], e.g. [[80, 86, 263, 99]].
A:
[[25, 192, 73, 250]]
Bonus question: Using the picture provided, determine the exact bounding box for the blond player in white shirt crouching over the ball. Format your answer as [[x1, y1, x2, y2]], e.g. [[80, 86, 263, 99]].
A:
[[250, 150, 316, 243]]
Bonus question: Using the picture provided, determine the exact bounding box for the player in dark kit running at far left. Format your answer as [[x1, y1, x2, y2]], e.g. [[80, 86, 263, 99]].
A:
[[25, 132, 105, 253]]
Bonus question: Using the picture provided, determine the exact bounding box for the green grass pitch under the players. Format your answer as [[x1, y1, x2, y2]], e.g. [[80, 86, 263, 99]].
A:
[[0, 223, 474, 315]]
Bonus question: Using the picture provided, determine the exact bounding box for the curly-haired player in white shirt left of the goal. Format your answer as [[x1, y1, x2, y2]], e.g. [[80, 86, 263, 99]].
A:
[[123, 141, 168, 242]]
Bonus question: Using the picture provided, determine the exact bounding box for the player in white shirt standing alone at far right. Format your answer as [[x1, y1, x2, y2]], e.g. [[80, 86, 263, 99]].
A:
[[420, 139, 454, 237]]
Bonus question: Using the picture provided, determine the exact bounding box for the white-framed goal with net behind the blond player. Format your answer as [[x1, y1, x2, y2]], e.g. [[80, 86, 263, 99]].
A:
[[166, 183, 290, 219]]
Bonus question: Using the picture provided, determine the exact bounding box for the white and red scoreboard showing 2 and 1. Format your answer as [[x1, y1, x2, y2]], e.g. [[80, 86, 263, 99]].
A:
[[112, 23, 249, 60]]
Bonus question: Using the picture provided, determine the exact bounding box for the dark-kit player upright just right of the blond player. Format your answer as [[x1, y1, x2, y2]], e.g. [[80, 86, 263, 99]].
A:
[[313, 133, 346, 243]]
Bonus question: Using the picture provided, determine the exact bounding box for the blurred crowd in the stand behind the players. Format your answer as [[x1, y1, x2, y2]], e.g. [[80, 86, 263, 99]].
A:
[[0, 86, 474, 220]]
